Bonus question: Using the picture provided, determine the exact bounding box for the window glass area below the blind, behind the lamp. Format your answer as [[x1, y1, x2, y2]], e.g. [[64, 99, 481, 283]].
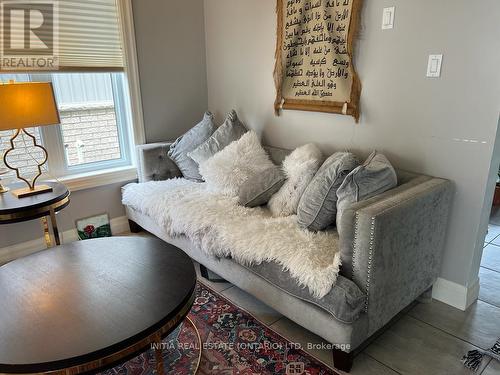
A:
[[0, 73, 131, 176]]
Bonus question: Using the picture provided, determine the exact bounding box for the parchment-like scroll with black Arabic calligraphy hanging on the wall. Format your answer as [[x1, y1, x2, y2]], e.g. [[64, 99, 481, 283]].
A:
[[274, 0, 362, 121]]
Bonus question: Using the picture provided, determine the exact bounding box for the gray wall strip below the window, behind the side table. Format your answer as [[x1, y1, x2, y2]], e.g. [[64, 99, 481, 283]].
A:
[[0, 184, 125, 249]]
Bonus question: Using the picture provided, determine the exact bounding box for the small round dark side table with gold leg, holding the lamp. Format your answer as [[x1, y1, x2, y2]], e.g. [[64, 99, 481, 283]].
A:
[[0, 182, 70, 247]]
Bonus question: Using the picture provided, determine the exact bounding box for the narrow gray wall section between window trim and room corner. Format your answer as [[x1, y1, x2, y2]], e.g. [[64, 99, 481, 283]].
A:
[[132, 0, 207, 142]]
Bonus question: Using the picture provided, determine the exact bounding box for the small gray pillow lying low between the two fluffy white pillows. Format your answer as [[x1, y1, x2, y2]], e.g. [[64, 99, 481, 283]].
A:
[[238, 167, 285, 207]]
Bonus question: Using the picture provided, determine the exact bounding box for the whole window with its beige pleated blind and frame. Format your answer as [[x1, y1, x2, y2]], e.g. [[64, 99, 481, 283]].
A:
[[0, 0, 143, 187]]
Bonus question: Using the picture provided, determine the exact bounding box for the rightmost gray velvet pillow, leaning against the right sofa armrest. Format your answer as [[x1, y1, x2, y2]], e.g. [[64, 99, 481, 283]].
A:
[[337, 151, 398, 223]]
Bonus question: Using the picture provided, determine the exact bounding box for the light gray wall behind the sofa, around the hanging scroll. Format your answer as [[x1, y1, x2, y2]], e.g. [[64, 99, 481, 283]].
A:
[[205, 0, 500, 304]]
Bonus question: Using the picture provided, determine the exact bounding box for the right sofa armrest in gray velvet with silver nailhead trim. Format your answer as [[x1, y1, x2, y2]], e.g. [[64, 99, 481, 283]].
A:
[[339, 177, 453, 334]]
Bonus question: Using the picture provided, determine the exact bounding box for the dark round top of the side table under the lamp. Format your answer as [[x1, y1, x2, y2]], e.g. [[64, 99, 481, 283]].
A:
[[0, 181, 70, 223]]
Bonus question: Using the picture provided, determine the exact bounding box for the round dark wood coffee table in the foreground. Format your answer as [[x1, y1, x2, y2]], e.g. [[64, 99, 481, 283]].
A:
[[0, 237, 196, 374]]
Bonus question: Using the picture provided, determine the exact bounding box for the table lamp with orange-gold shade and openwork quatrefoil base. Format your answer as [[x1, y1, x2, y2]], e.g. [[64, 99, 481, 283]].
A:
[[0, 81, 60, 198]]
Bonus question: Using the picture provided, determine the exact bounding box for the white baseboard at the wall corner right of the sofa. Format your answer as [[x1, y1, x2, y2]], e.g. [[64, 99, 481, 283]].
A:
[[432, 278, 479, 311]]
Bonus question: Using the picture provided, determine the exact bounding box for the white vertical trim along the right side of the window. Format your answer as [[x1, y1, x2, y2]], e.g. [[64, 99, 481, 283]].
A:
[[117, 0, 146, 145]]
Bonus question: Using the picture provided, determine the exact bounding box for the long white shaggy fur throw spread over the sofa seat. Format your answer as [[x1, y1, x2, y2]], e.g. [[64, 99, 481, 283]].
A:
[[122, 178, 340, 298]]
